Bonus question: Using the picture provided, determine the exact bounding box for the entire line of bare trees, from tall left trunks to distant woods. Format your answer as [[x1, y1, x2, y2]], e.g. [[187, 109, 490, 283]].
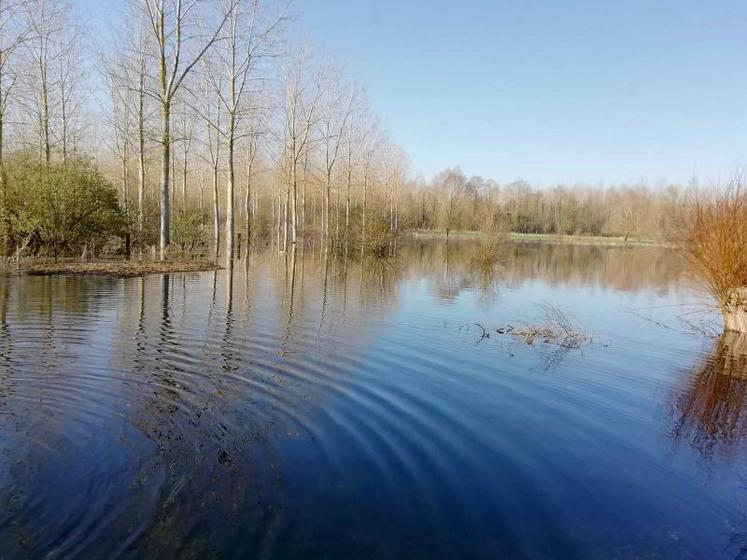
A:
[[0, 0, 700, 266]]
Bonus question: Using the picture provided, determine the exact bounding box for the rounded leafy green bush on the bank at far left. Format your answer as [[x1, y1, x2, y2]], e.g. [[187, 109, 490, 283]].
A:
[[1, 154, 126, 256]]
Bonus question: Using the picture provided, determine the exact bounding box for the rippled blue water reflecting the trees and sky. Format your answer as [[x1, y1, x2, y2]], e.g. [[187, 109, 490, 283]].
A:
[[0, 242, 747, 559]]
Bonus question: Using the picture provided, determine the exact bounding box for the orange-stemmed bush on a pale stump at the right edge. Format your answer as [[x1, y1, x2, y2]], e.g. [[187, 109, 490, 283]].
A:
[[682, 176, 747, 332]]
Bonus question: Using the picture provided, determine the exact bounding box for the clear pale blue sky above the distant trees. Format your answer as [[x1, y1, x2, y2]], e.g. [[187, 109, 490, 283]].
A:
[[78, 0, 747, 184]]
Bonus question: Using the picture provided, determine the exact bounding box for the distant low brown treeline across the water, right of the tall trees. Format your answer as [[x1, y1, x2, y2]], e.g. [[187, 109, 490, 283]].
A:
[[403, 168, 687, 241]]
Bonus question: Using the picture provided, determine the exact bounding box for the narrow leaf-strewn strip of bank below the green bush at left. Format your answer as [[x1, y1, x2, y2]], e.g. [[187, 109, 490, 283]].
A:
[[22, 261, 222, 278]]
